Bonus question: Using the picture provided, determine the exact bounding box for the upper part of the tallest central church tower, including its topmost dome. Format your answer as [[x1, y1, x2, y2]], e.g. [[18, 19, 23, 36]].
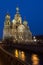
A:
[[12, 7, 22, 28]]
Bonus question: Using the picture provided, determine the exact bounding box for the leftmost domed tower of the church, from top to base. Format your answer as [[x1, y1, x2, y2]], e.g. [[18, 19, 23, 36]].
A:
[[3, 13, 10, 39]]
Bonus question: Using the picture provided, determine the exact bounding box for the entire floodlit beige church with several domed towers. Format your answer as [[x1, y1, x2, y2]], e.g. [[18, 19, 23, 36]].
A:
[[3, 7, 32, 41]]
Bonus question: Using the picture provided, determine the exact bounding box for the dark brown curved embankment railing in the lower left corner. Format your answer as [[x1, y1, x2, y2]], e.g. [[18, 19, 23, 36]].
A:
[[0, 47, 28, 65]]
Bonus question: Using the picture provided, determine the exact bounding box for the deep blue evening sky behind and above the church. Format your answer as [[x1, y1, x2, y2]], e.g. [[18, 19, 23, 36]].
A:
[[0, 0, 43, 38]]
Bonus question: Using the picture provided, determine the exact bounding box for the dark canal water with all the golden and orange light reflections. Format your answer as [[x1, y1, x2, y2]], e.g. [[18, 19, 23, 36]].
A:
[[5, 48, 43, 65]]
